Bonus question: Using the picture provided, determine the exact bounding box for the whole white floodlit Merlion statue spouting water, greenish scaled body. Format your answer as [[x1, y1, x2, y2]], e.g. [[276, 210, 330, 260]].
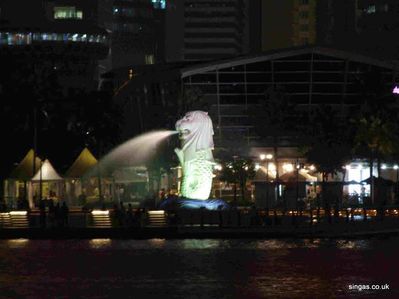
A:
[[175, 111, 215, 200]]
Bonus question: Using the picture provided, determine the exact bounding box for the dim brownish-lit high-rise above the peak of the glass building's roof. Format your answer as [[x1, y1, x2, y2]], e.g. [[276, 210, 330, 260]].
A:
[[261, 0, 317, 51]]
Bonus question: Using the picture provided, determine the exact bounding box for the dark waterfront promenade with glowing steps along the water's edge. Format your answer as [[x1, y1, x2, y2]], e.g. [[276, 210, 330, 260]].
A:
[[0, 208, 399, 239]]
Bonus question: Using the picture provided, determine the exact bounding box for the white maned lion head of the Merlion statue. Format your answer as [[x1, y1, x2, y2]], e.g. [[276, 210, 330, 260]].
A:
[[176, 111, 214, 152]]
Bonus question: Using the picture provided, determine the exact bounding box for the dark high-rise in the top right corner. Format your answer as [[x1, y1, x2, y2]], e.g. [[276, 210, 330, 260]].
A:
[[317, 0, 399, 60]]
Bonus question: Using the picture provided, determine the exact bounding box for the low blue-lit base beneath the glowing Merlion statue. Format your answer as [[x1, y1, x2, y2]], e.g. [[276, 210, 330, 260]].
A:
[[159, 197, 230, 211]]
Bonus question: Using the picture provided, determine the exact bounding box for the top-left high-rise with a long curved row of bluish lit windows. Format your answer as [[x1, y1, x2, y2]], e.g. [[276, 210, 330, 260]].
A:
[[0, 0, 108, 89]]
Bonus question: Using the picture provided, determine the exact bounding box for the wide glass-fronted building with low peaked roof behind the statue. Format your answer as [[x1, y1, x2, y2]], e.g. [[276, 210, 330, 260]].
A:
[[181, 47, 398, 146]]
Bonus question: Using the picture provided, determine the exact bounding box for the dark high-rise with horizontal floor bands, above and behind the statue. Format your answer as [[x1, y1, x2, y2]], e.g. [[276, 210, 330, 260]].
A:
[[165, 0, 259, 62]]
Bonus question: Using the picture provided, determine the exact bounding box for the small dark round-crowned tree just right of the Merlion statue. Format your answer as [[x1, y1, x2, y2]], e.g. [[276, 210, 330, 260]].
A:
[[220, 157, 256, 204]]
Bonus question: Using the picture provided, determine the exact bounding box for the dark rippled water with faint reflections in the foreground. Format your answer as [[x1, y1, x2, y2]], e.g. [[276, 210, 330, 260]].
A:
[[0, 238, 399, 299]]
